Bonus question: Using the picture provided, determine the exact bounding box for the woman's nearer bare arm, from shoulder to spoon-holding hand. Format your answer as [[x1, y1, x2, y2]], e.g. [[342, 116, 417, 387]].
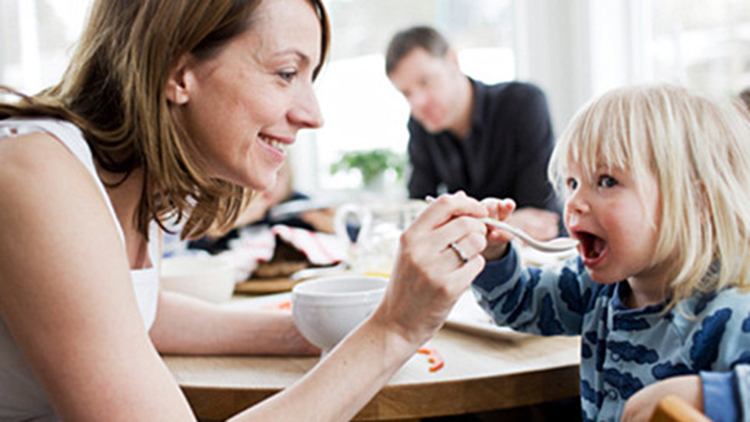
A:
[[0, 135, 486, 422]]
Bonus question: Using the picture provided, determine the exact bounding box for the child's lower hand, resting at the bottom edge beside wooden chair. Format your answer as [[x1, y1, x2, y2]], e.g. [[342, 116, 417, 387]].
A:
[[620, 375, 703, 422]]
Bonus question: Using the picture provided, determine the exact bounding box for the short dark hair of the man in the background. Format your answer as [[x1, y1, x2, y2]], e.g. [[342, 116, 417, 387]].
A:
[[385, 26, 450, 75]]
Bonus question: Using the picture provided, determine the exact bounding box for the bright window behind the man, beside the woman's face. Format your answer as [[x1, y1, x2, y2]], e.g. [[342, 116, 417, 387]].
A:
[[293, 0, 515, 195]]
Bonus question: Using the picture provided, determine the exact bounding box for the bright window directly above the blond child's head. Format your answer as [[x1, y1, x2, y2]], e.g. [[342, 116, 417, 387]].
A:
[[588, 0, 750, 97]]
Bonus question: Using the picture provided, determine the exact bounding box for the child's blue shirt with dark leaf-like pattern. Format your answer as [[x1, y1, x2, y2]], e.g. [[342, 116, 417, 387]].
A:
[[473, 247, 750, 421]]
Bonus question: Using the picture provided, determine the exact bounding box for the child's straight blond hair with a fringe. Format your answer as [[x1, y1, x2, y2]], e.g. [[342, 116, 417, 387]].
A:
[[549, 85, 750, 308]]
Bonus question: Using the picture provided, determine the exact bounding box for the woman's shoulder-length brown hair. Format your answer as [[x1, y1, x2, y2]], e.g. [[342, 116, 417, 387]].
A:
[[0, 0, 330, 238]]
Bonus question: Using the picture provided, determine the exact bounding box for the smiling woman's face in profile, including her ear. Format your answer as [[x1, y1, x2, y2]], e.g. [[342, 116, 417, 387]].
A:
[[175, 0, 323, 190]]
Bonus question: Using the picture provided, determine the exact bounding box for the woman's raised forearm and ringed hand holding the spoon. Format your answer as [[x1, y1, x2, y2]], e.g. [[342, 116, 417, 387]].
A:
[[233, 194, 486, 421]]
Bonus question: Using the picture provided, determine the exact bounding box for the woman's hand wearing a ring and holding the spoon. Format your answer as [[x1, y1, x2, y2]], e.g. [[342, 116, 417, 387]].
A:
[[373, 192, 488, 346]]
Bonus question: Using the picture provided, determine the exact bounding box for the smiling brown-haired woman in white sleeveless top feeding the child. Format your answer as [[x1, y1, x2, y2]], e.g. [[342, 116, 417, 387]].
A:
[[0, 0, 486, 421]]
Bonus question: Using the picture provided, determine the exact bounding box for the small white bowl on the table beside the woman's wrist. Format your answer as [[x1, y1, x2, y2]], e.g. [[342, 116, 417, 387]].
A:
[[292, 275, 388, 355]]
